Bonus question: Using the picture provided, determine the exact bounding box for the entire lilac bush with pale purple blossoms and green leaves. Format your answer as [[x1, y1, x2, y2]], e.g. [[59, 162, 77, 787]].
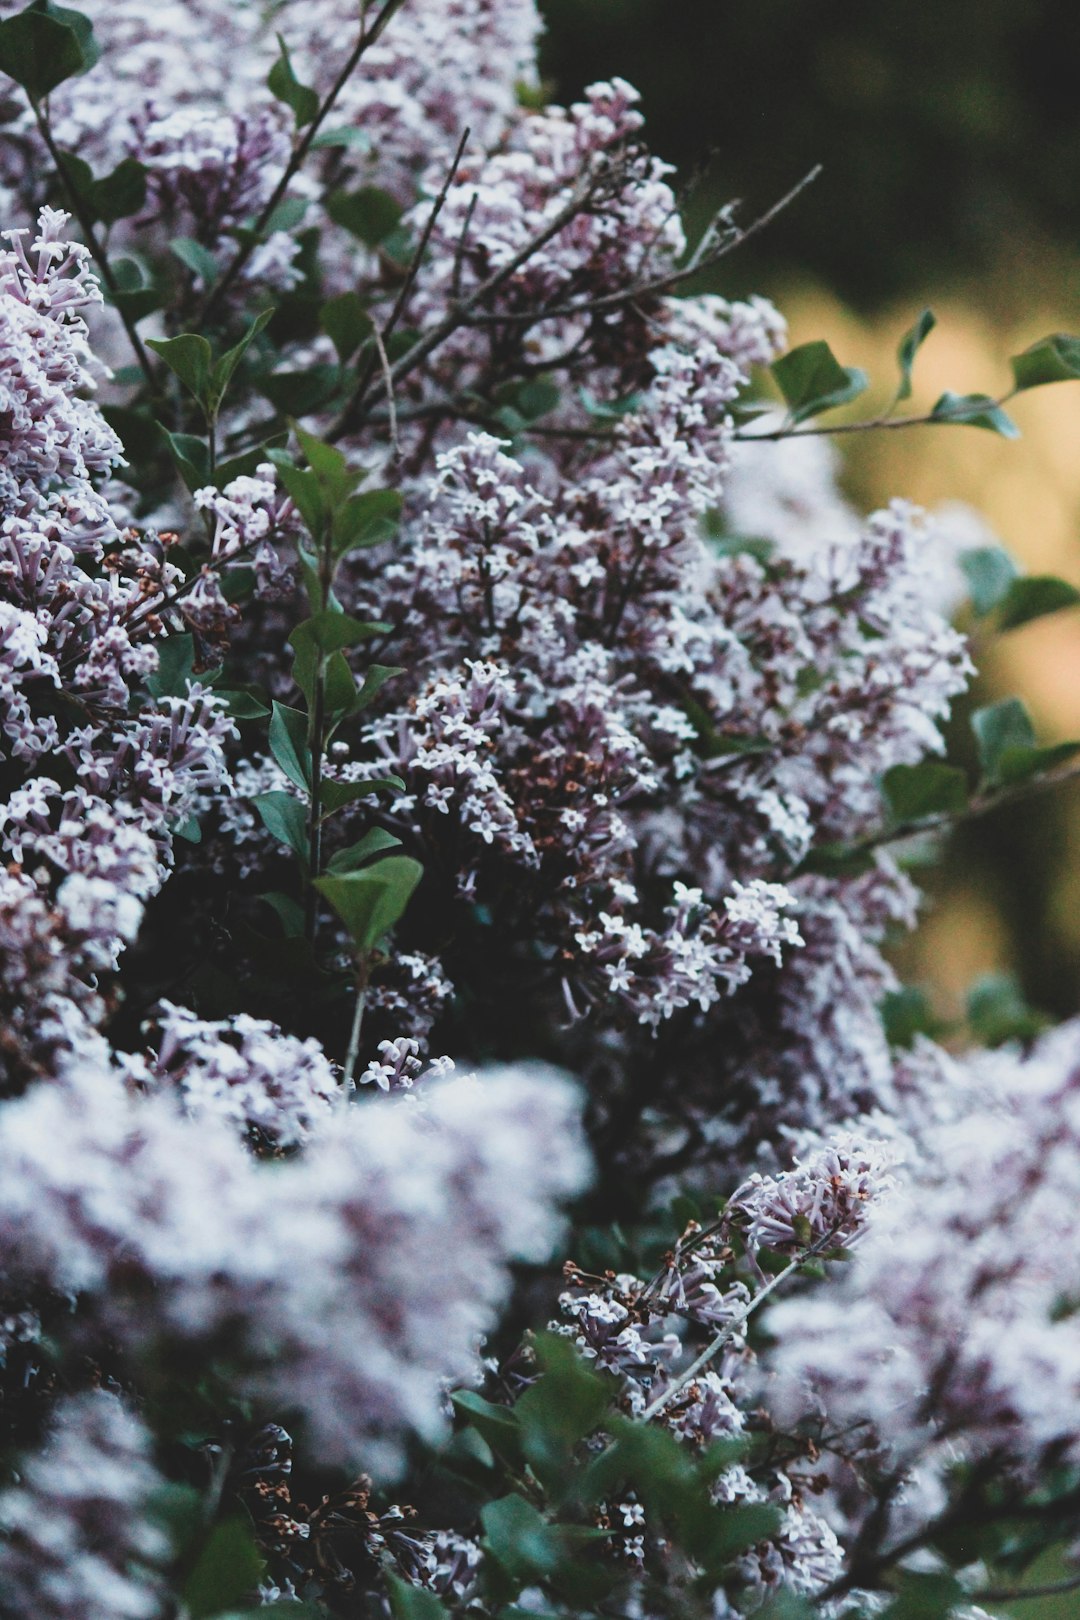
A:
[[0, 0, 1080, 1620]]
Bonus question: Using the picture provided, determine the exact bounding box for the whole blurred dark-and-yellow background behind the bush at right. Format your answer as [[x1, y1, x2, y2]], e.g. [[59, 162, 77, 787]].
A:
[[541, 0, 1080, 1049]]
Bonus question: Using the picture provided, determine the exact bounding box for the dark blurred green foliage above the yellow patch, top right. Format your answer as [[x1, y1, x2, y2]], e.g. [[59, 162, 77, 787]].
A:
[[541, 0, 1080, 308]]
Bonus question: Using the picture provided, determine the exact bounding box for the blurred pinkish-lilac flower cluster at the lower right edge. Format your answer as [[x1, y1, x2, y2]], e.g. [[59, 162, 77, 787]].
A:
[[769, 1024, 1080, 1473]]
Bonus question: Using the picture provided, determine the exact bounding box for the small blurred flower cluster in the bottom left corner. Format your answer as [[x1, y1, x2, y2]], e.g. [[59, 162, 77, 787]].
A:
[[0, 1390, 170, 1620]]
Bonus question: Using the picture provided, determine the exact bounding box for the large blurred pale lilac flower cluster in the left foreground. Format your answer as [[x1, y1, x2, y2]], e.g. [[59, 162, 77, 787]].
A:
[[0, 1069, 586, 1473]]
